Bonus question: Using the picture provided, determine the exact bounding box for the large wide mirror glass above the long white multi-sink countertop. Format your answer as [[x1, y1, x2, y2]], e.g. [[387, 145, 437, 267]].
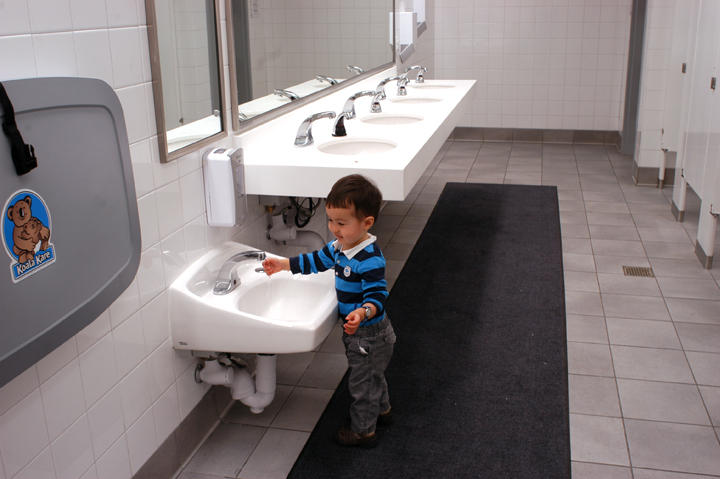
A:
[[226, 0, 394, 131]]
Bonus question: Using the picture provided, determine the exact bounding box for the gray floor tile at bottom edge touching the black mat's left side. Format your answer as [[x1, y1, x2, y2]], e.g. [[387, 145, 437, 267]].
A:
[[239, 429, 310, 479]]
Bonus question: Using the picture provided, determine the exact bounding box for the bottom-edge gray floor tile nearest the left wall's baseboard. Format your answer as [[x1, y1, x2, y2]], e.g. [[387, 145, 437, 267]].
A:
[[185, 423, 265, 477]]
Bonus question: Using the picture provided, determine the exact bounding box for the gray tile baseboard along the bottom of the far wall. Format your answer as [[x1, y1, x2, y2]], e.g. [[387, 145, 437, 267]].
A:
[[448, 126, 622, 148]]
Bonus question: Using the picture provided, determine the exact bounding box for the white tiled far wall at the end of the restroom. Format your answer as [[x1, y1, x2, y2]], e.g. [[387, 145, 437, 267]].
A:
[[435, 0, 631, 130]]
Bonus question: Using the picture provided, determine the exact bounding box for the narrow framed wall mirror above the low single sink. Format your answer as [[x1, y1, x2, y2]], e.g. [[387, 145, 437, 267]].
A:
[[145, 0, 227, 163]]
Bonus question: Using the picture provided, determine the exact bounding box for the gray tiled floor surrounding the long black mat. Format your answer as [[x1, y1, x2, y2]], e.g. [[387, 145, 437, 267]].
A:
[[179, 141, 720, 479]]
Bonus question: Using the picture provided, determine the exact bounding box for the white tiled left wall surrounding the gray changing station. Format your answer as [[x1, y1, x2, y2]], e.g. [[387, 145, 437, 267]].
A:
[[0, 0, 325, 479]]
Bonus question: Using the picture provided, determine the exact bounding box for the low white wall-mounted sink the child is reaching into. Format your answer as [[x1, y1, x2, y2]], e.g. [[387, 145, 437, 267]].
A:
[[168, 241, 338, 354]]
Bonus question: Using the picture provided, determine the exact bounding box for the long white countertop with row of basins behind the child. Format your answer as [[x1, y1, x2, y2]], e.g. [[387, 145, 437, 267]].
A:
[[233, 68, 475, 201]]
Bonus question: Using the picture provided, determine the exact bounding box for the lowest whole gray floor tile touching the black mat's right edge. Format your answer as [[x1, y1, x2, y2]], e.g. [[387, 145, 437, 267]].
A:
[[570, 414, 630, 466]]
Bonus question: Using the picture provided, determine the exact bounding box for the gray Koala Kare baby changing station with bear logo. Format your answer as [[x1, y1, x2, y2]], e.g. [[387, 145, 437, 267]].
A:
[[0, 78, 141, 387]]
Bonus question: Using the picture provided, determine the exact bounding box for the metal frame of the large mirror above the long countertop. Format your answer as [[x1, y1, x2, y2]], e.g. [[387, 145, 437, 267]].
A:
[[225, 0, 397, 135]]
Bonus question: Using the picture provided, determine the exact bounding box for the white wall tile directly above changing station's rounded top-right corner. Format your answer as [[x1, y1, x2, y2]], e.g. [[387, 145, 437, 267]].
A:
[[73, 29, 115, 86]]
